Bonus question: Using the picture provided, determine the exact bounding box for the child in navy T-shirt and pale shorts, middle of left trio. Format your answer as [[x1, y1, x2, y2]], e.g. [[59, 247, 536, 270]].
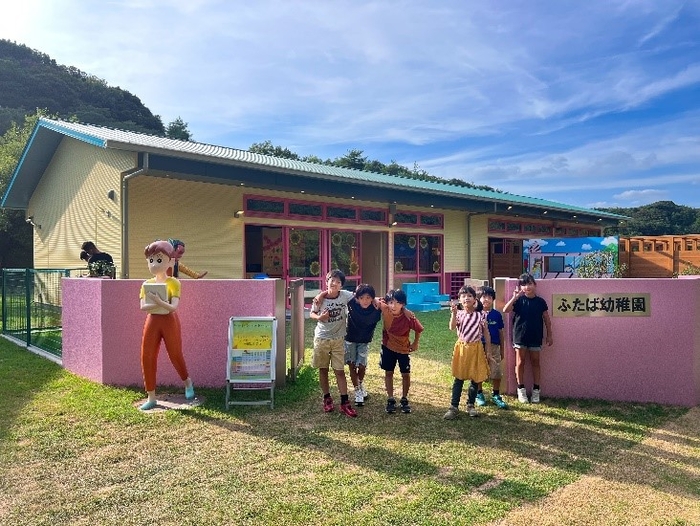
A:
[[345, 283, 382, 406]]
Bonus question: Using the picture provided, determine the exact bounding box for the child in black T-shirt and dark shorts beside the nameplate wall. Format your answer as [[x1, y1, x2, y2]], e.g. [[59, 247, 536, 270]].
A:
[[503, 274, 553, 404]]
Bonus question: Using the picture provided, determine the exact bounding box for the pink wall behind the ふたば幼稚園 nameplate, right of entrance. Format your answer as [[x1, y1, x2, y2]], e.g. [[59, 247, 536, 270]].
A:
[[497, 278, 700, 406]]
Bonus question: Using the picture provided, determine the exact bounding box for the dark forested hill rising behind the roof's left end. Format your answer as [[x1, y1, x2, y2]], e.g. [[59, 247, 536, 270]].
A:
[[0, 40, 165, 135]]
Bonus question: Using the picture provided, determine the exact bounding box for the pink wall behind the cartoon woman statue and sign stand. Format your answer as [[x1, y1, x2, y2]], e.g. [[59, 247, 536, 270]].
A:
[[62, 278, 286, 387]]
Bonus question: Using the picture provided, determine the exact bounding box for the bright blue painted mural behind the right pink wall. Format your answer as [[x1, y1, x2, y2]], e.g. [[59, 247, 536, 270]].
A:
[[522, 236, 618, 279]]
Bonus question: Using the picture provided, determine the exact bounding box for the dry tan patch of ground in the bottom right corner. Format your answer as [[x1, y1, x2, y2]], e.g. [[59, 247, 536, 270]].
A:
[[490, 407, 700, 526]]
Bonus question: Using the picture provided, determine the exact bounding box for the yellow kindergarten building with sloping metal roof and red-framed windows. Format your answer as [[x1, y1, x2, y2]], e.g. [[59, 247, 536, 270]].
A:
[[0, 118, 627, 295]]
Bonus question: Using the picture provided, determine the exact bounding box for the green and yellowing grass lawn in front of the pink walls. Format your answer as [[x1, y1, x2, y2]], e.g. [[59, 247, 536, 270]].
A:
[[0, 311, 700, 526]]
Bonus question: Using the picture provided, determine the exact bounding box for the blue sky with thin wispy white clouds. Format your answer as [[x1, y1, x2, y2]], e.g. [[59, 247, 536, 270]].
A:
[[0, 0, 700, 208]]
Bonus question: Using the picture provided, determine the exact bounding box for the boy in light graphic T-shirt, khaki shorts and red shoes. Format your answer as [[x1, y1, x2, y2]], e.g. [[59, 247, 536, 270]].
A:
[[309, 269, 357, 417]]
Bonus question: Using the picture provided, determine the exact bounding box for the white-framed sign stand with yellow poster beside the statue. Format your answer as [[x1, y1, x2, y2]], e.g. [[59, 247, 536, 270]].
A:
[[226, 316, 277, 409]]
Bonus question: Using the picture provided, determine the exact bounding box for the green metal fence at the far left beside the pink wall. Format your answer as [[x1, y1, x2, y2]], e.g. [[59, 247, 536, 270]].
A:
[[0, 268, 82, 357]]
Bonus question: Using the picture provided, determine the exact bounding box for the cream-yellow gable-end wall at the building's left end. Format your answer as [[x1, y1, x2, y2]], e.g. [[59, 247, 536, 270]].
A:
[[27, 137, 136, 272]]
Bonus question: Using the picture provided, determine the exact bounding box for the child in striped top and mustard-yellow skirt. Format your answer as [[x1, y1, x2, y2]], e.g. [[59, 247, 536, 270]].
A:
[[443, 285, 491, 420]]
